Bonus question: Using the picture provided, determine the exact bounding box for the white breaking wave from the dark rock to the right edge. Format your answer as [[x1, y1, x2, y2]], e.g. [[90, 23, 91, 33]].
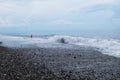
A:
[[50, 36, 120, 57]]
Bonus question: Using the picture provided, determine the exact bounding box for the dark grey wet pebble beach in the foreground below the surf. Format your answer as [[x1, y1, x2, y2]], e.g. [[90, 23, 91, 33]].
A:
[[0, 47, 120, 80]]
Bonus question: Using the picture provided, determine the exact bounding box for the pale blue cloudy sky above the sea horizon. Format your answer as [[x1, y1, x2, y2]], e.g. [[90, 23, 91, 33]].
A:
[[0, 0, 120, 34]]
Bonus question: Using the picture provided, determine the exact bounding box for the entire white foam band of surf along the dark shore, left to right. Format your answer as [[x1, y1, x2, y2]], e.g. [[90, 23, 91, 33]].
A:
[[0, 35, 120, 57]]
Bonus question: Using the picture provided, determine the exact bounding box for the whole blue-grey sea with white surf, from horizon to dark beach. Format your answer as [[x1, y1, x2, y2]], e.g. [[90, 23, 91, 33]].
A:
[[0, 27, 120, 57]]
